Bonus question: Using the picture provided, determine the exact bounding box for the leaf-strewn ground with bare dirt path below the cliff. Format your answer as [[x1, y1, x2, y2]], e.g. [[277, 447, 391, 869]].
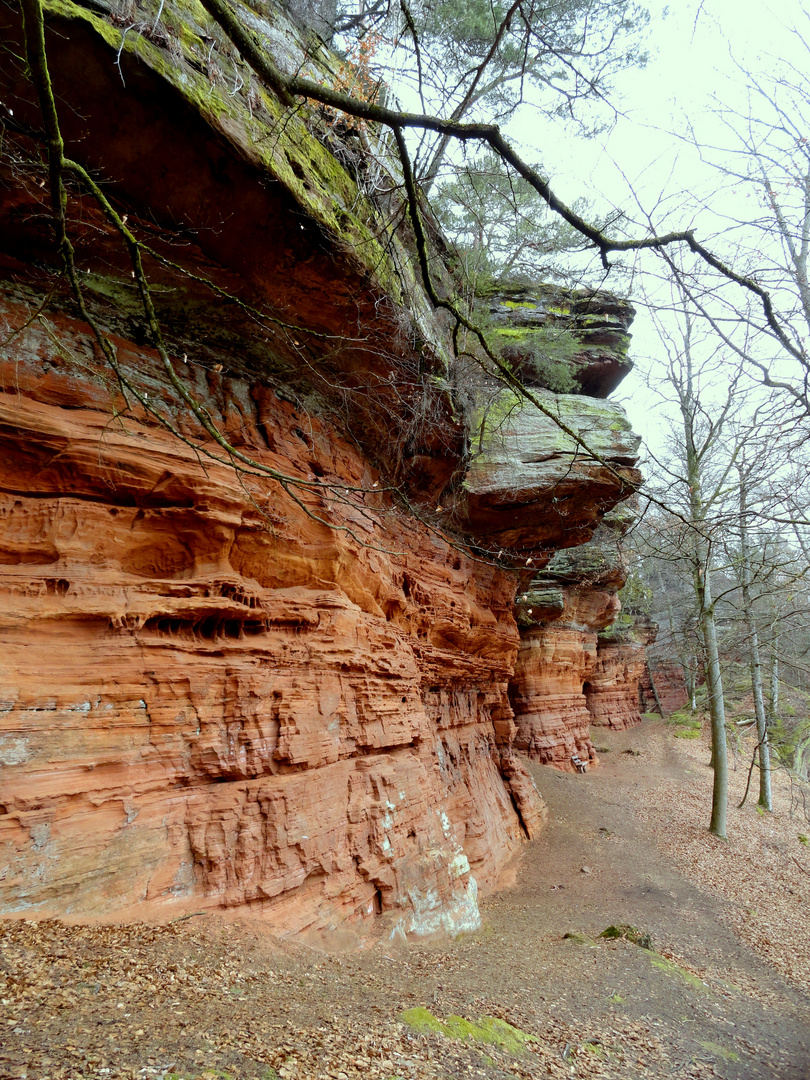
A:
[[0, 719, 810, 1080]]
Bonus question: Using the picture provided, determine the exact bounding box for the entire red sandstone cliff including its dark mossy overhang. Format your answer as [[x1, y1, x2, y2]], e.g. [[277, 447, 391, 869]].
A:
[[0, 0, 639, 934]]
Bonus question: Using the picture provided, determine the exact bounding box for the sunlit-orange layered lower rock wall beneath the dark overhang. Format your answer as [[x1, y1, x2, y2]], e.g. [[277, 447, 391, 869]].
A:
[[0, 308, 543, 931]]
